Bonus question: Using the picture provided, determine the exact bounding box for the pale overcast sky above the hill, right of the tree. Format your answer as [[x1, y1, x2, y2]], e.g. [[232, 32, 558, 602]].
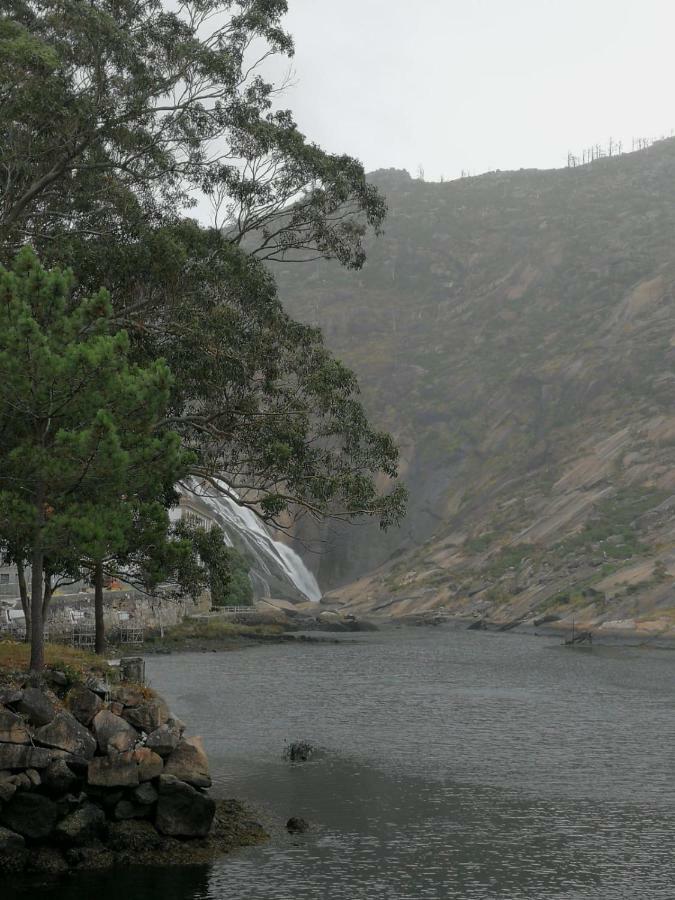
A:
[[270, 0, 675, 180]]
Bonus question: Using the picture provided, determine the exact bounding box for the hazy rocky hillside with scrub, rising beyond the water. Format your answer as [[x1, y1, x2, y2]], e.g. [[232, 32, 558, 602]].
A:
[[277, 140, 675, 624]]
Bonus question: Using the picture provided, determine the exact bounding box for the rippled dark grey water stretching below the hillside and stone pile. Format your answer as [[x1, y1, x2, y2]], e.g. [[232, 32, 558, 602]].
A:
[[11, 628, 675, 900]]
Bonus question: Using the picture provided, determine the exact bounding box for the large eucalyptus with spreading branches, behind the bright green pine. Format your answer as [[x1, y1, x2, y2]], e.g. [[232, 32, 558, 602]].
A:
[[0, 0, 404, 540]]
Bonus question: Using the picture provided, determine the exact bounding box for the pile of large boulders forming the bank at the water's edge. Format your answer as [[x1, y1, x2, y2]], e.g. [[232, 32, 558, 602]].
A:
[[0, 672, 216, 868]]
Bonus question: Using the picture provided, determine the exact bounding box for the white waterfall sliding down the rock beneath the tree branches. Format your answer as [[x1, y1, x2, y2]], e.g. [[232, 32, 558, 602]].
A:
[[174, 479, 321, 603]]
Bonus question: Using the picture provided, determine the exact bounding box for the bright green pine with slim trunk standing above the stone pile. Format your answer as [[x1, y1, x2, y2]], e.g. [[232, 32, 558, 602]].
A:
[[0, 249, 184, 670]]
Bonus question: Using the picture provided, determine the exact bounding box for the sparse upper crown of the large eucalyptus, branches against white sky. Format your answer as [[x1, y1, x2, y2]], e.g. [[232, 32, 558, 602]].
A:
[[0, 0, 385, 268]]
